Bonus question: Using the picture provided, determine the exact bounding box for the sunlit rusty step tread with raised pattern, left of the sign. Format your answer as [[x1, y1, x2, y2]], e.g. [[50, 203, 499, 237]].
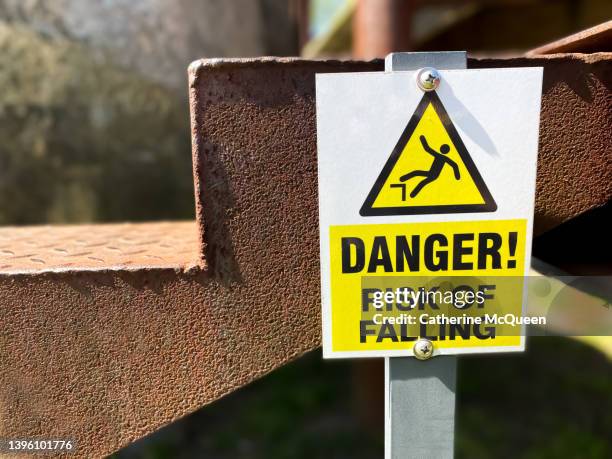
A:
[[0, 222, 198, 275]]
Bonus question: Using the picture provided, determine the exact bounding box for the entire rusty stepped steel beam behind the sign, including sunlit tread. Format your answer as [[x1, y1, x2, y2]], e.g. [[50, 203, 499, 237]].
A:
[[0, 54, 612, 457]]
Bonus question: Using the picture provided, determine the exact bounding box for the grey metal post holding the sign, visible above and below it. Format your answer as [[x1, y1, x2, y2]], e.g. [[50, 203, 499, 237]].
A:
[[385, 51, 467, 459]]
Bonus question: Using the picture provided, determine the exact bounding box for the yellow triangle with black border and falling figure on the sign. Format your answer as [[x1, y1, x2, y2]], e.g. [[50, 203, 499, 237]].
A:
[[359, 92, 497, 217]]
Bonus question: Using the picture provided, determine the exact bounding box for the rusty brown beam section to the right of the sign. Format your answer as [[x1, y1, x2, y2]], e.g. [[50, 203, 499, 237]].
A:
[[468, 53, 612, 235]]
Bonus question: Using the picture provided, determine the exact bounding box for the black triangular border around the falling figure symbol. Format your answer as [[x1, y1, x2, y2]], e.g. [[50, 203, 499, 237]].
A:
[[359, 91, 497, 217]]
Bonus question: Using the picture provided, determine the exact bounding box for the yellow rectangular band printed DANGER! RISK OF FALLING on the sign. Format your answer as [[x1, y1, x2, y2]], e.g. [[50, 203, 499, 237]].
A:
[[329, 220, 526, 351]]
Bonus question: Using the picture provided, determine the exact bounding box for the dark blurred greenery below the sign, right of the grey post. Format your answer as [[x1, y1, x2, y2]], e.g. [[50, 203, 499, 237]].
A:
[[456, 337, 612, 459]]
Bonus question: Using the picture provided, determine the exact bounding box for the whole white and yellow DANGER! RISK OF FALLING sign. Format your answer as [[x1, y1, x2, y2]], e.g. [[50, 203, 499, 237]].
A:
[[316, 68, 542, 357]]
